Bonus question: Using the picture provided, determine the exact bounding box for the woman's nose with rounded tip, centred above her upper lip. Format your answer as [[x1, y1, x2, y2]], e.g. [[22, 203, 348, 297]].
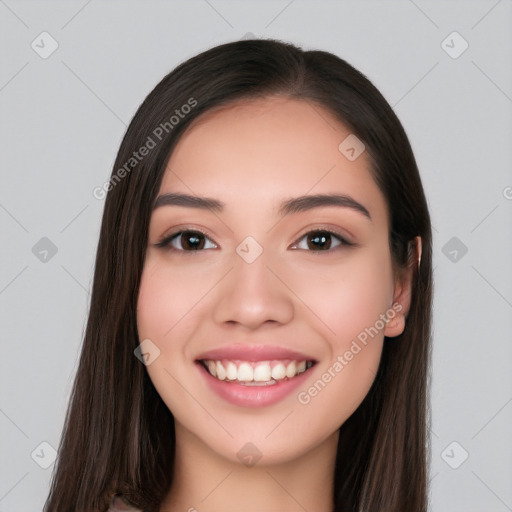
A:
[[213, 252, 295, 330]]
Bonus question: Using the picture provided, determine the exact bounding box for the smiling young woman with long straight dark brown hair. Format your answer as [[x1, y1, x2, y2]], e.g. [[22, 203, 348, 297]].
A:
[[45, 40, 432, 512]]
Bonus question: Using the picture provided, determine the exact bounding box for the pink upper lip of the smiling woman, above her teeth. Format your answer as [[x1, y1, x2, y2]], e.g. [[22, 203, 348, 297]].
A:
[[196, 344, 316, 362]]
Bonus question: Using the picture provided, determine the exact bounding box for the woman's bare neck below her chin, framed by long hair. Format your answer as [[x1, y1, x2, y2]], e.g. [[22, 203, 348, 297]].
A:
[[160, 425, 338, 512]]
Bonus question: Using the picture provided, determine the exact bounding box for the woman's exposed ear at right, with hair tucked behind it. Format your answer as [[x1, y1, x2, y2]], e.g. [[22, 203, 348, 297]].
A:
[[384, 236, 421, 338]]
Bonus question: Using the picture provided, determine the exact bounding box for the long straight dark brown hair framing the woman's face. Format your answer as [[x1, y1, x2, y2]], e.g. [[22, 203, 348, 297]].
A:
[[44, 39, 432, 512]]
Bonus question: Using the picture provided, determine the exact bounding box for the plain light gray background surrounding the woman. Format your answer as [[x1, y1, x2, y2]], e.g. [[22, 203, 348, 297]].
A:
[[0, 0, 512, 512]]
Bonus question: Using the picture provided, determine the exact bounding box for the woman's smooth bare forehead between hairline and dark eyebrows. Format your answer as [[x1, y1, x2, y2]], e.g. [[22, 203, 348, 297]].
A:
[[160, 97, 387, 228]]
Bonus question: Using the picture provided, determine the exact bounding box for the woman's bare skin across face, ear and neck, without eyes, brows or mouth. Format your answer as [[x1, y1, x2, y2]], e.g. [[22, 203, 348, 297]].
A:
[[137, 97, 411, 512]]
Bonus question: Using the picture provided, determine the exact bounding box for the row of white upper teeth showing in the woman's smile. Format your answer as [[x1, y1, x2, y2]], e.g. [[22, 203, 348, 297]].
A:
[[204, 359, 313, 383]]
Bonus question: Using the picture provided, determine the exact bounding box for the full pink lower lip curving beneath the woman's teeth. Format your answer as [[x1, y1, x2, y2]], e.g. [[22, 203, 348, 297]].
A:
[[196, 363, 311, 407]]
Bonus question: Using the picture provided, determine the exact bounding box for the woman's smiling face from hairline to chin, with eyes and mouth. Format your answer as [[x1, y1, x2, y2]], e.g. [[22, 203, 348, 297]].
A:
[[137, 97, 408, 464]]
